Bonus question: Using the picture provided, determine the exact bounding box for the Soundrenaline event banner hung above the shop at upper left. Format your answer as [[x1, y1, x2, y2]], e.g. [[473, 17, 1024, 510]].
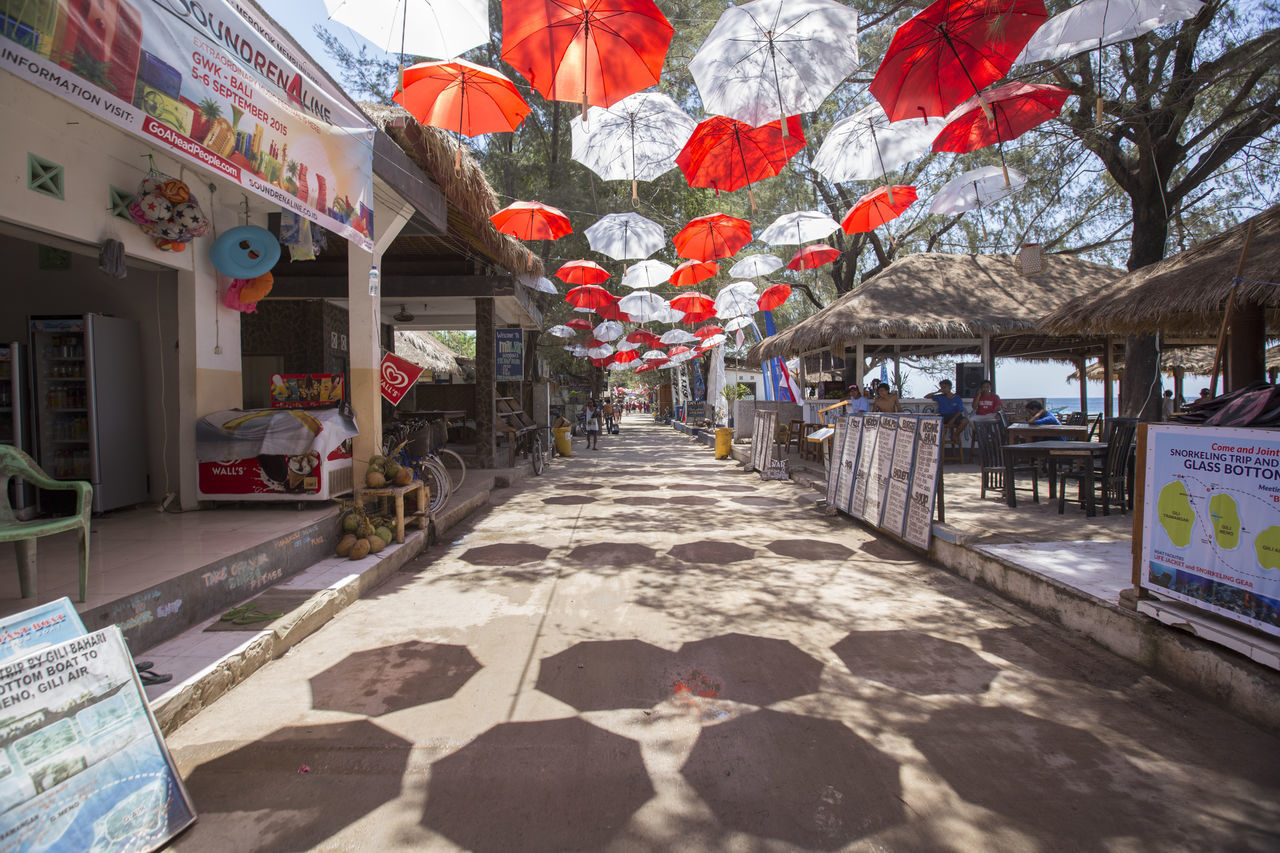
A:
[[0, 0, 374, 252]]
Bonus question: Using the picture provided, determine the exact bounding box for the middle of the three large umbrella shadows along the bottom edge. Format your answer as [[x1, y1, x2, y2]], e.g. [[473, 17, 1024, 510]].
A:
[[421, 717, 654, 853]]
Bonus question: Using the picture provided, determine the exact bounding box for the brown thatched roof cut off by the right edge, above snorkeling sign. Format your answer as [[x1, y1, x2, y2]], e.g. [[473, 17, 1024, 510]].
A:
[[1043, 205, 1280, 336]]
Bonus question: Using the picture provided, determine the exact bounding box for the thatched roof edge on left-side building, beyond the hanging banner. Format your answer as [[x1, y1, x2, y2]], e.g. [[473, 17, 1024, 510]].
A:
[[360, 104, 543, 275]]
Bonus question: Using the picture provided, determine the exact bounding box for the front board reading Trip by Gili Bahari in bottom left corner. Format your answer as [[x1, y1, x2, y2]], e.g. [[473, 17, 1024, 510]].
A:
[[0, 625, 196, 850]]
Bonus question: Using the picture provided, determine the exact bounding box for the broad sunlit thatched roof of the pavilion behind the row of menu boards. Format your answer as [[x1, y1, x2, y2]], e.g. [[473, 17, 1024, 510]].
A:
[[748, 254, 1124, 361]]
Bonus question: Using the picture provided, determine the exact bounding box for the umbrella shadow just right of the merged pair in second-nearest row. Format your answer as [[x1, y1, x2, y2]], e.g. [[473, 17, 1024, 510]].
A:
[[831, 630, 1000, 695]]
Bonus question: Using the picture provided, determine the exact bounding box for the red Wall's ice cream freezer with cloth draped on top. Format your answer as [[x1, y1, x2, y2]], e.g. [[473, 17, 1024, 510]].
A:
[[196, 409, 360, 501]]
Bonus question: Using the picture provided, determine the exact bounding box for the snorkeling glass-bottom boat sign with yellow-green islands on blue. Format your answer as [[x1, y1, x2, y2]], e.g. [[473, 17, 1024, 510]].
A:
[[1142, 424, 1280, 637]]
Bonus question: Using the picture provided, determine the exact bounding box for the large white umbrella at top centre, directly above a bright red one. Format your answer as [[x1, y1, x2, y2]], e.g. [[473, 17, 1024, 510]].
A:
[[689, 0, 858, 126]]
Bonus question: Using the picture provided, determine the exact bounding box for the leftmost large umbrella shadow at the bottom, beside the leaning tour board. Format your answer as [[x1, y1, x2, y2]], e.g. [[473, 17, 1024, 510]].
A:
[[186, 720, 412, 852]]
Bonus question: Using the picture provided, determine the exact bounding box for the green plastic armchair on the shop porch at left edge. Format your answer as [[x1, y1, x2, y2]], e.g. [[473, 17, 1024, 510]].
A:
[[0, 444, 93, 602]]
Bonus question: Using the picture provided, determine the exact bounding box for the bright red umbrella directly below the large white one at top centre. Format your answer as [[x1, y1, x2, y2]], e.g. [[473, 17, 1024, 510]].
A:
[[676, 115, 804, 206]]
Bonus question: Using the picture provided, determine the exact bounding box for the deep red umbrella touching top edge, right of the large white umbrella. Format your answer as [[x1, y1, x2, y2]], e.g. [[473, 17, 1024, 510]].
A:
[[870, 0, 1048, 122]]
